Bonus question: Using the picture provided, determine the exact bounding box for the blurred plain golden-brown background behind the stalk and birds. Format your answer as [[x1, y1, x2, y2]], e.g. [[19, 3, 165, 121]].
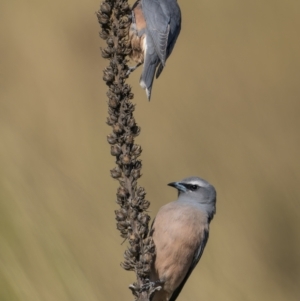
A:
[[0, 0, 300, 301]]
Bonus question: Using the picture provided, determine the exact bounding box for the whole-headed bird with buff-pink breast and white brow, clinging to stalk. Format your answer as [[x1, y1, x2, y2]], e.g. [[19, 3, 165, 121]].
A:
[[150, 177, 216, 301]]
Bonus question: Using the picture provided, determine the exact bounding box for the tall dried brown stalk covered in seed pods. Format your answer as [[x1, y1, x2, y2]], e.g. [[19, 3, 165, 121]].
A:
[[97, 0, 160, 301]]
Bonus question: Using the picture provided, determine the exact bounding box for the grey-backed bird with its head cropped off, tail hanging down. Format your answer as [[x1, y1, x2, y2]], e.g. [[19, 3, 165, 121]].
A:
[[129, 0, 181, 100]]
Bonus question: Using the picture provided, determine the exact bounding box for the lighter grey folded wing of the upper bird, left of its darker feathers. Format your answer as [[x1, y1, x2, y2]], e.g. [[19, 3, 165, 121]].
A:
[[142, 0, 172, 65]]
